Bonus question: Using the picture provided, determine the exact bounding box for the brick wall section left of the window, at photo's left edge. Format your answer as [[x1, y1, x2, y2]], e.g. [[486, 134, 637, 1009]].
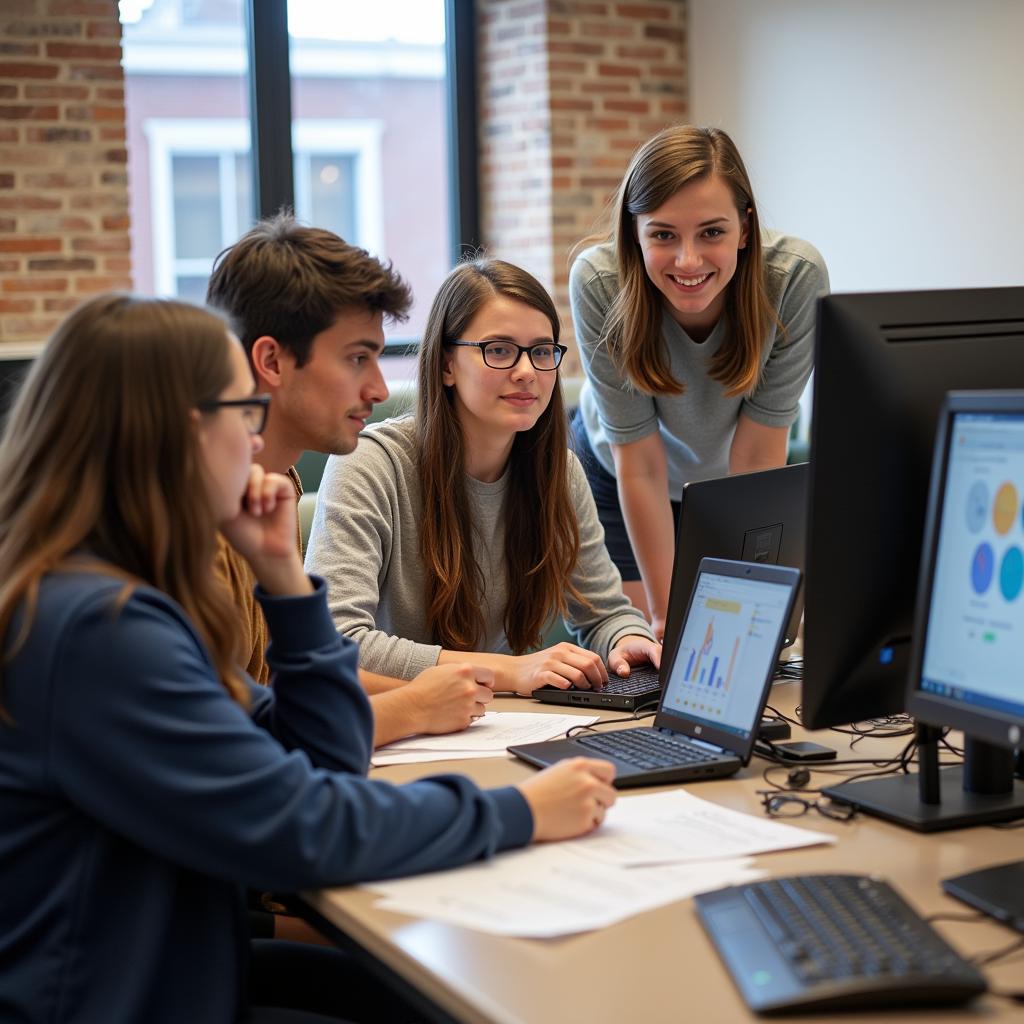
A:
[[0, 0, 131, 344]]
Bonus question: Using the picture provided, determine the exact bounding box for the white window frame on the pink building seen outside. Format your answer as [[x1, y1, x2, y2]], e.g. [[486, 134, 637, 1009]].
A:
[[142, 118, 384, 296]]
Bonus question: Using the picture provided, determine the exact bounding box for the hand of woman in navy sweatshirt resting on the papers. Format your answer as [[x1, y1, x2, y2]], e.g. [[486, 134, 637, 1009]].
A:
[[518, 758, 616, 843]]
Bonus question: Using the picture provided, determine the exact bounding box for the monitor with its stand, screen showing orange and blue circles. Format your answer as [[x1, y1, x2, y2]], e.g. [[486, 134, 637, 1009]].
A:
[[826, 391, 1024, 831]]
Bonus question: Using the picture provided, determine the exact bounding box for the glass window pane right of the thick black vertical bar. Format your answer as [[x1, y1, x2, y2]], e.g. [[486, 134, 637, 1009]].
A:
[[288, 0, 451, 356]]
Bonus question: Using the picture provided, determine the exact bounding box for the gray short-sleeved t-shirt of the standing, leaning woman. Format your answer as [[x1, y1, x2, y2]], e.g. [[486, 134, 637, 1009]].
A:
[[569, 231, 828, 500]]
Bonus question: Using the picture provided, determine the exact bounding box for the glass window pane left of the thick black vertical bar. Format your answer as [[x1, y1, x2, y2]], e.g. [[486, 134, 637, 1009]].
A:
[[120, 0, 252, 296]]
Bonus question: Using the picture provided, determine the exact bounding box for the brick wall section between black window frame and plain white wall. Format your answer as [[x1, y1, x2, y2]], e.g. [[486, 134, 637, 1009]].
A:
[[477, 0, 687, 373]]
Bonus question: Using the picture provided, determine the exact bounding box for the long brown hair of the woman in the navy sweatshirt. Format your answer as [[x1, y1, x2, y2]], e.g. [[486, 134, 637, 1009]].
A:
[[0, 295, 248, 707]]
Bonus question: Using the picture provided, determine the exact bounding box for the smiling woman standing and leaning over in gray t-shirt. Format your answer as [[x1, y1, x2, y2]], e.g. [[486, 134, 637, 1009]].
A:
[[569, 125, 828, 637]]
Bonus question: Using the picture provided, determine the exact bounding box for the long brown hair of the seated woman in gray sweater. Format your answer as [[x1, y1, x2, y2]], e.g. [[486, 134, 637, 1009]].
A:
[[416, 257, 588, 654]]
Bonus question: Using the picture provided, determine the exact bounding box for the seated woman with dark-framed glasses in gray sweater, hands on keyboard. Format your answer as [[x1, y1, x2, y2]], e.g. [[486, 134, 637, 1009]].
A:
[[306, 258, 660, 694]]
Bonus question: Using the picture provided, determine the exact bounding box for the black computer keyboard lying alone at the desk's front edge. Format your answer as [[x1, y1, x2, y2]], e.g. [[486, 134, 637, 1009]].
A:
[[695, 874, 987, 1014]]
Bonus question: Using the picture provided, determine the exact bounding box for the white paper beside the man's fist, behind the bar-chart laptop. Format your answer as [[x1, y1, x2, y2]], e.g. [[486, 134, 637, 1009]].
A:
[[372, 711, 598, 766]]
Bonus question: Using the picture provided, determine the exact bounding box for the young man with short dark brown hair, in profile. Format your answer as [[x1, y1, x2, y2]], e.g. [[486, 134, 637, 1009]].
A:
[[207, 213, 494, 745]]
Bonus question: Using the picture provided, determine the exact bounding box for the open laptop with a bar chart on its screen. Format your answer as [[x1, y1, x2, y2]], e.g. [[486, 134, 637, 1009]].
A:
[[509, 558, 800, 787]]
